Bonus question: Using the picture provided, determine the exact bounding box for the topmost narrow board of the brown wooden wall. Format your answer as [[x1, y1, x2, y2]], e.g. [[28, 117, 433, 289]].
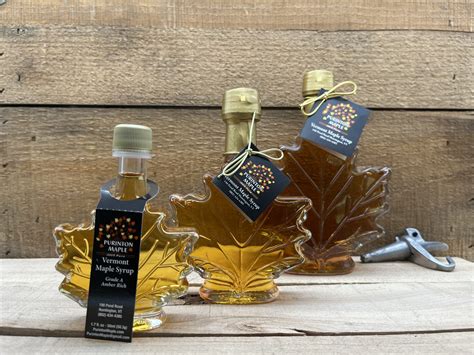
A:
[[0, 0, 473, 31]]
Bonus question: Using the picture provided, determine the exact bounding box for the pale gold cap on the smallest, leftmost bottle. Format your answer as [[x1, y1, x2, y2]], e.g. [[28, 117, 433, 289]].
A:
[[112, 124, 152, 158]]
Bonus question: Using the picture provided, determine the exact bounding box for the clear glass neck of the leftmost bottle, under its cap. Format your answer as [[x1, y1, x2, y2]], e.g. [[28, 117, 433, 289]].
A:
[[114, 157, 147, 200]]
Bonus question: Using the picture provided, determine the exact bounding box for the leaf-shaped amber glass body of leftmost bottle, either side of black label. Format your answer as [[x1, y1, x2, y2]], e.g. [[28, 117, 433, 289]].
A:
[[54, 209, 195, 329]]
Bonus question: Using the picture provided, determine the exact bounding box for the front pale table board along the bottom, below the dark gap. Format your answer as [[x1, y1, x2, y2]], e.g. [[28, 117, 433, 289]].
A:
[[0, 332, 474, 354]]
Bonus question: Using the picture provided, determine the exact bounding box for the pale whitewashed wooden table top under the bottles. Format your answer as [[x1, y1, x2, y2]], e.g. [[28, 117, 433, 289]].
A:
[[0, 258, 474, 354]]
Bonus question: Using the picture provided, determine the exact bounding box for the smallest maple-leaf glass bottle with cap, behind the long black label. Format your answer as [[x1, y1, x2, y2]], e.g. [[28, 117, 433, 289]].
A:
[[54, 125, 198, 331]]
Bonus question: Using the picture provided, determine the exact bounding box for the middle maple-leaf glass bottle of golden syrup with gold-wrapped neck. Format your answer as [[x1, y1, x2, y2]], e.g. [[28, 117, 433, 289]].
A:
[[170, 88, 310, 304]]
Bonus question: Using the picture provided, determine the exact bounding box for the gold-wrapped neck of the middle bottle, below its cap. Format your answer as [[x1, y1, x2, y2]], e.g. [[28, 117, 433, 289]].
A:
[[224, 114, 257, 162]]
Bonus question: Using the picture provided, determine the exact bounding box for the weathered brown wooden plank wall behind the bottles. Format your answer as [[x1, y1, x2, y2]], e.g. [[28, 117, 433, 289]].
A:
[[0, 0, 474, 260]]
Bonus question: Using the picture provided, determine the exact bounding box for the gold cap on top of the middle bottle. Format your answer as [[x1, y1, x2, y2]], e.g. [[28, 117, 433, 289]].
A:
[[222, 88, 262, 121]]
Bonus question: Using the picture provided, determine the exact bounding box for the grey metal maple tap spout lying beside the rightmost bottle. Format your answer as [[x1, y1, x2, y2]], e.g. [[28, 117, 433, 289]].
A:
[[360, 228, 456, 271]]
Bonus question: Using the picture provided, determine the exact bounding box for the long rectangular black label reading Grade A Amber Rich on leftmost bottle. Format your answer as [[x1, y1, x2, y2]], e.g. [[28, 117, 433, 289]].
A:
[[85, 181, 157, 342]]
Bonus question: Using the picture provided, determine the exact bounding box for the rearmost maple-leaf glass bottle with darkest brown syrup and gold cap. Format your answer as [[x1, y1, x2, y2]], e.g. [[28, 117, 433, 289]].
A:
[[280, 70, 390, 275]]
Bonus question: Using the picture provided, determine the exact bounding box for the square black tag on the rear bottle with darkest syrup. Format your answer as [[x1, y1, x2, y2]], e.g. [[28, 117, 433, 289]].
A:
[[300, 90, 370, 157]]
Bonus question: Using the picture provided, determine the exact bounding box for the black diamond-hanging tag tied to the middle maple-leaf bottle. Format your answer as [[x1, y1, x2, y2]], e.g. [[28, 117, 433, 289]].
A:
[[213, 144, 290, 221]]
